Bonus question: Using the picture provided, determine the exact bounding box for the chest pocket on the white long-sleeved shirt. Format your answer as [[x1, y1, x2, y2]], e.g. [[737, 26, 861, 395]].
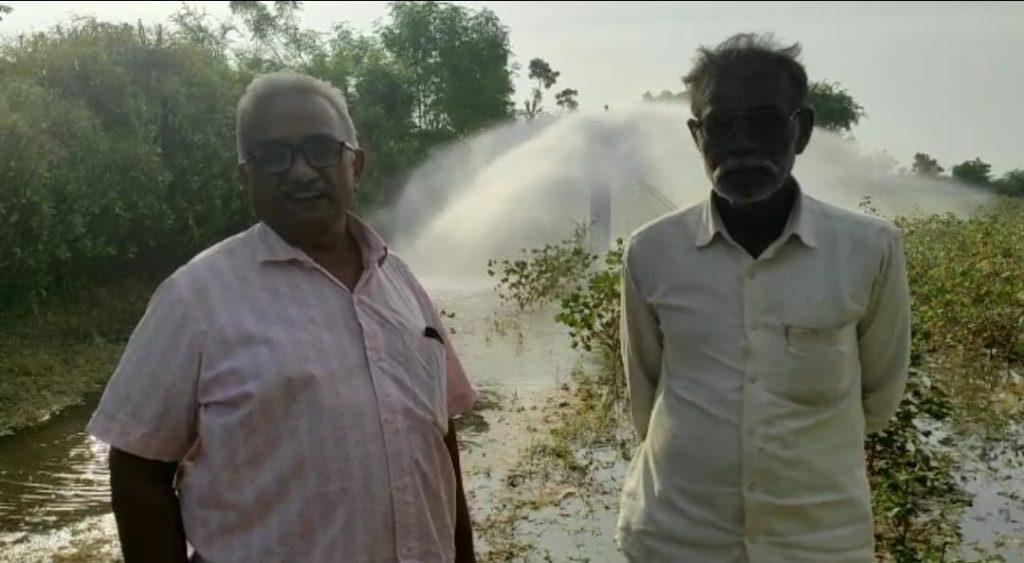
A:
[[776, 322, 856, 404]]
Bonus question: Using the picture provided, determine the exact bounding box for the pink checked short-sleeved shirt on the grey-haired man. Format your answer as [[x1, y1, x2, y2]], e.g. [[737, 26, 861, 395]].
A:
[[88, 217, 475, 563]]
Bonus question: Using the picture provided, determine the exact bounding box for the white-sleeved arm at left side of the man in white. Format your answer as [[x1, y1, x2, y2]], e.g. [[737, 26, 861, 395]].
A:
[[620, 242, 662, 440]]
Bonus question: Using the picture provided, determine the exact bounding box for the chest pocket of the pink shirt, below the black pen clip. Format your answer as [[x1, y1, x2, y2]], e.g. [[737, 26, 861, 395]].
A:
[[402, 329, 447, 433]]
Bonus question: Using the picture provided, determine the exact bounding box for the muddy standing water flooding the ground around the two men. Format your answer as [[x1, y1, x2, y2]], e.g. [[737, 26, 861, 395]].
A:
[[0, 285, 1024, 563]]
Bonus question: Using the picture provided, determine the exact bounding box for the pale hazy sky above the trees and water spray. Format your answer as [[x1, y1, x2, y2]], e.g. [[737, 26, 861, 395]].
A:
[[0, 0, 1024, 173]]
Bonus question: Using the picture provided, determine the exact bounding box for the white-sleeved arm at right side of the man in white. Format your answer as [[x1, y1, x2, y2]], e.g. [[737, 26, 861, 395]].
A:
[[857, 228, 910, 434]]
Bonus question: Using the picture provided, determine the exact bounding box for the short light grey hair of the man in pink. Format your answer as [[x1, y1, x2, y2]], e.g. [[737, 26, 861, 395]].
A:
[[234, 73, 359, 163]]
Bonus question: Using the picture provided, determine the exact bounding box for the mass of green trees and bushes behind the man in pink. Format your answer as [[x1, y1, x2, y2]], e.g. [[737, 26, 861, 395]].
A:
[[0, 2, 516, 314]]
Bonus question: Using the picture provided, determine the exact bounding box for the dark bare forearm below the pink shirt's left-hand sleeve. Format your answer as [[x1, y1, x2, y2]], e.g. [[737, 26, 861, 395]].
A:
[[110, 447, 188, 563]]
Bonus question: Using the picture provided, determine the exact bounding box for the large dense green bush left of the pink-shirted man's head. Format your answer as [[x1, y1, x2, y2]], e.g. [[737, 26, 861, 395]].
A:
[[0, 19, 249, 310]]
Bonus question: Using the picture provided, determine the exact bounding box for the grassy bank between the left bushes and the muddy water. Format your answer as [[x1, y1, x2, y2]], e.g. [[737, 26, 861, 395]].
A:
[[0, 278, 157, 436]]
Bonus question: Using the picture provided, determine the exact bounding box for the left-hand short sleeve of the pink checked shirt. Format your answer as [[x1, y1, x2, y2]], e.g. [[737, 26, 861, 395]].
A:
[[86, 276, 203, 462]]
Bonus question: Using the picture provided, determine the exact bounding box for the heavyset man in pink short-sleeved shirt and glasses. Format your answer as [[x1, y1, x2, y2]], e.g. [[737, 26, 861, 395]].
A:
[[88, 74, 475, 563]]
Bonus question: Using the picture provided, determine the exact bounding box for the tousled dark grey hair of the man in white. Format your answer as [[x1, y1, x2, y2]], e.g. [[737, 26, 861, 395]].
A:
[[683, 33, 808, 116]]
